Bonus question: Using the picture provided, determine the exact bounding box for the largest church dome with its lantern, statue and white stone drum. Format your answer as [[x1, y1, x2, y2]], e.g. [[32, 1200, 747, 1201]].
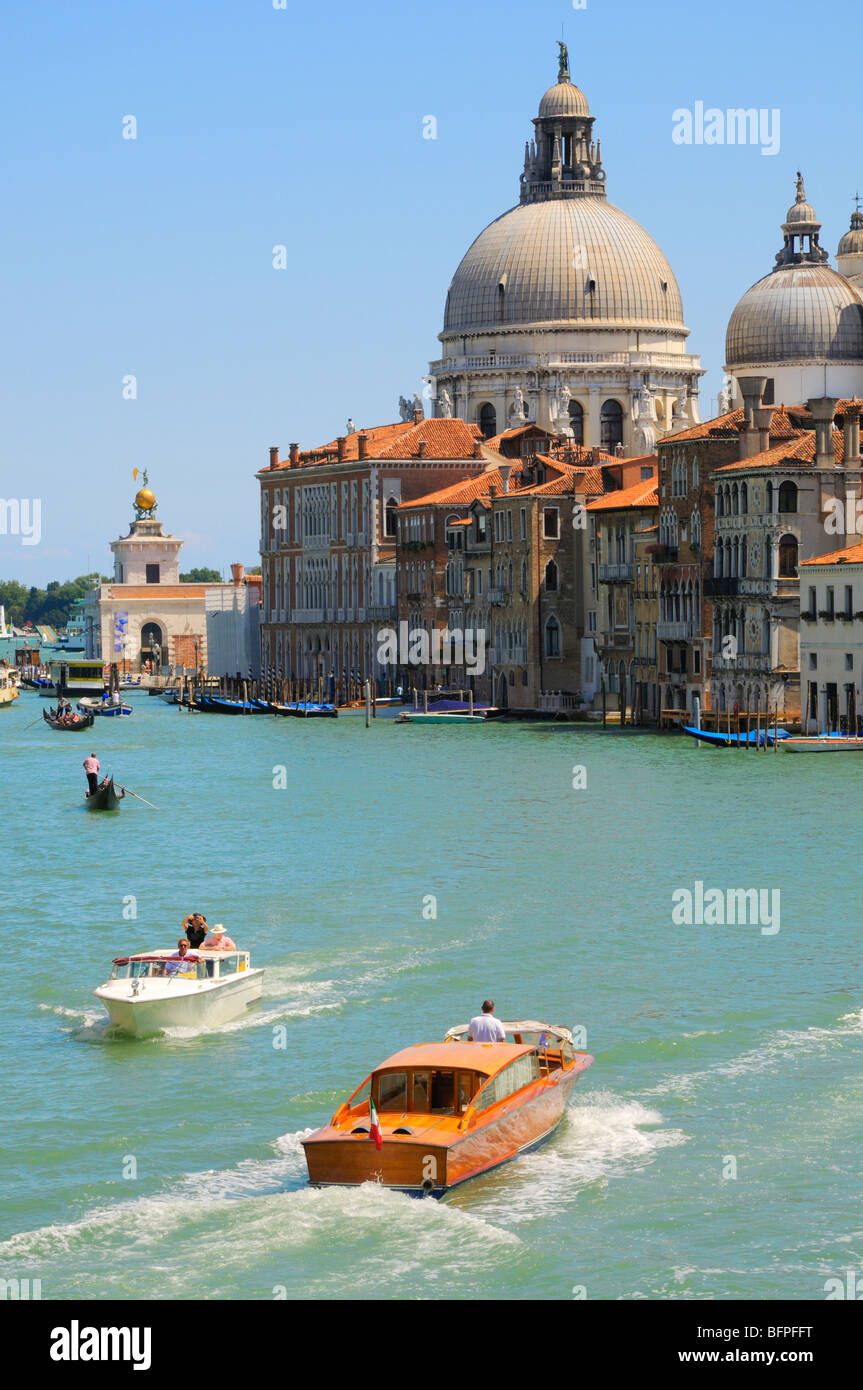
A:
[[429, 44, 702, 453]]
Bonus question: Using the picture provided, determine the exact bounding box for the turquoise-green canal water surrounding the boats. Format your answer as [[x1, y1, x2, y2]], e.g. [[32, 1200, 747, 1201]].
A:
[[0, 695, 863, 1300]]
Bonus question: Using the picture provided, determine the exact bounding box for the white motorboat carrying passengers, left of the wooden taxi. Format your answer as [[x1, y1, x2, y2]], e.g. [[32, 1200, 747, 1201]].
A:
[[93, 947, 264, 1037]]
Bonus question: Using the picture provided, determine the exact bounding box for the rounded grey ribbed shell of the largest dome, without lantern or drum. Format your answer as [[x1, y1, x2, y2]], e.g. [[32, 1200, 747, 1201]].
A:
[[443, 197, 684, 335]]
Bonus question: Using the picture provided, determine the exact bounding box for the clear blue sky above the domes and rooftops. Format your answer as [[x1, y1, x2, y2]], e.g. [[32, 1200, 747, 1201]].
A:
[[0, 0, 863, 584]]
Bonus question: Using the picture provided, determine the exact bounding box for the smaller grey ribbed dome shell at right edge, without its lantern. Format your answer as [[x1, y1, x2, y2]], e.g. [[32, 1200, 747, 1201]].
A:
[[725, 264, 863, 368]]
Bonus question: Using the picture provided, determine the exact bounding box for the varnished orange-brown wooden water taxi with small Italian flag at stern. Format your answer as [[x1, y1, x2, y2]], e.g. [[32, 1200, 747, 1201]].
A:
[[303, 1022, 593, 1197]]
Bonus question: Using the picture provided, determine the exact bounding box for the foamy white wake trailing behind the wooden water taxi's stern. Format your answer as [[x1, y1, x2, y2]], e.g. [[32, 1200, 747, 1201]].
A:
[[0, 1130, 516, 1298]]
